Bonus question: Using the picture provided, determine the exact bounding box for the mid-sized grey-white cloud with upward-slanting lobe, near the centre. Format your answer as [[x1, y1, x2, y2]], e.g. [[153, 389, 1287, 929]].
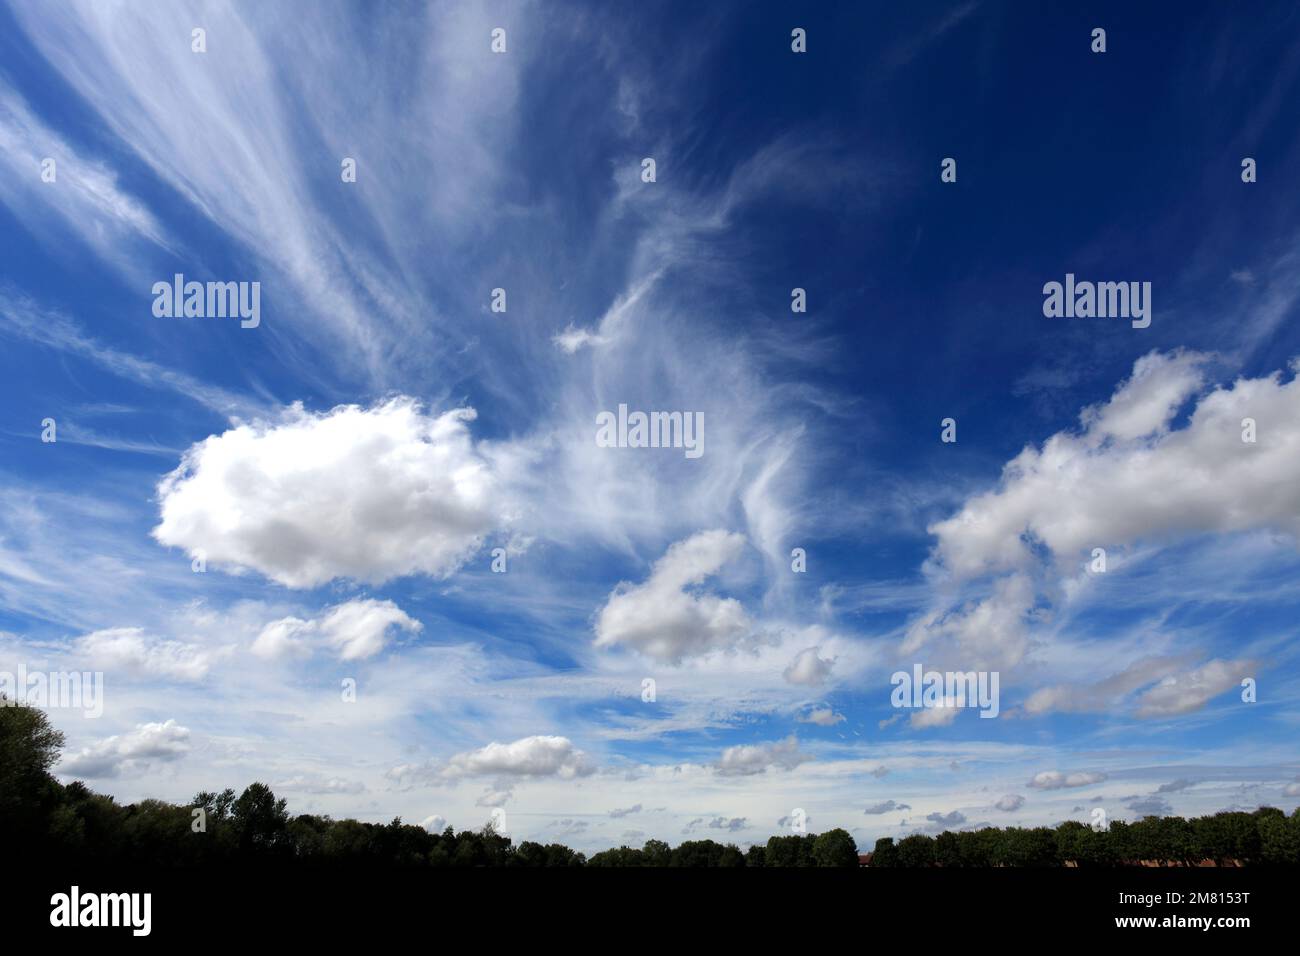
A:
[[595, 531, 753, 663]]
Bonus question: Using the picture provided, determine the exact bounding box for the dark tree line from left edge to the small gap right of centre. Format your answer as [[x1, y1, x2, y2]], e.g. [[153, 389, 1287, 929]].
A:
[[0, 695, 858, 869]]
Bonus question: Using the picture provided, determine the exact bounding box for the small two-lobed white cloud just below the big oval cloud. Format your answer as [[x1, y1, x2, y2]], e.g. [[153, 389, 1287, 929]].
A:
[[252, 598, 423, 661]]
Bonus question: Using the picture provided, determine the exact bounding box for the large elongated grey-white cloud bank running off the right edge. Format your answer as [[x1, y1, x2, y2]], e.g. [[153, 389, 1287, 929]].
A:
[[902, 351, 1300, 671]]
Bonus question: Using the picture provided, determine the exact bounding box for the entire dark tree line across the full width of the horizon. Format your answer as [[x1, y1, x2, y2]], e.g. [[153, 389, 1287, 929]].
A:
[[0, 696, 1300, 868]]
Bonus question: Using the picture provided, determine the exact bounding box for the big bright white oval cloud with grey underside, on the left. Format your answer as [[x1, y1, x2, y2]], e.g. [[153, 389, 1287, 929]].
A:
[[153, 398, 504, 588]]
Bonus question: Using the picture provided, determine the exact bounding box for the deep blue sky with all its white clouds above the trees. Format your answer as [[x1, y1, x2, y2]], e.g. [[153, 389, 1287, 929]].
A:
[[0, 1, 1300, 849]]
